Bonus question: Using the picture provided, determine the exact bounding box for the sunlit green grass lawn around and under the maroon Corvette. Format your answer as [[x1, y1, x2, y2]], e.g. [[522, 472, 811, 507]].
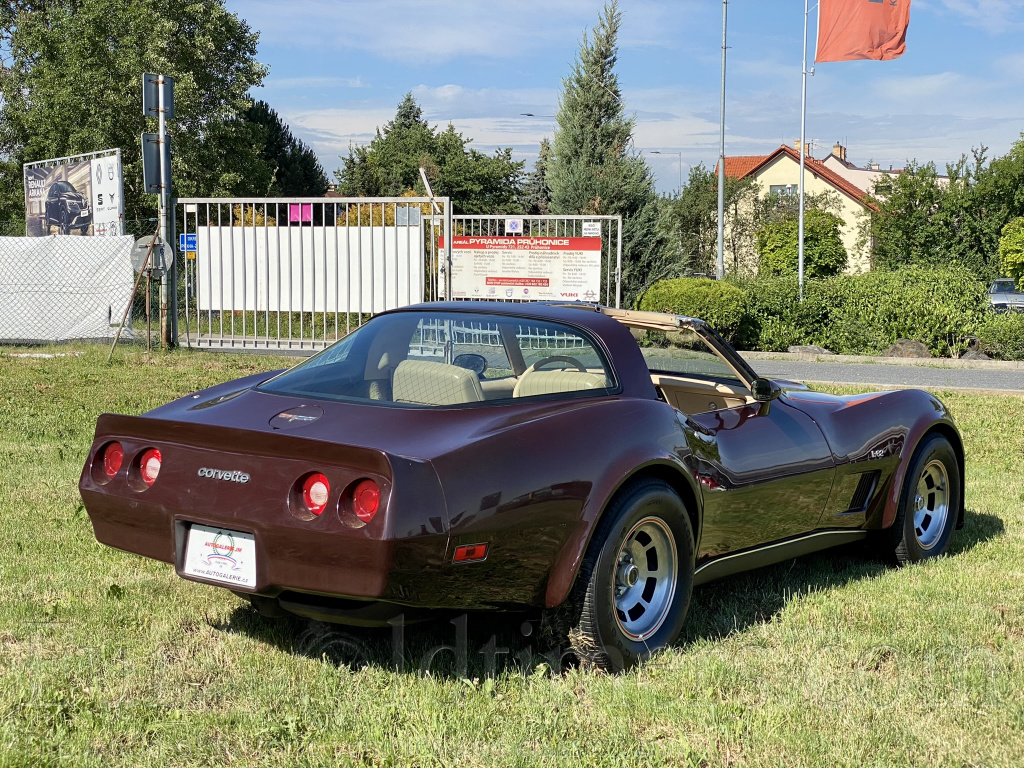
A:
[[0, 346, 1024, 768]]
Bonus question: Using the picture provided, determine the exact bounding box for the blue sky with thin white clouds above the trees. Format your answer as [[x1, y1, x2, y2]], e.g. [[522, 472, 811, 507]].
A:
[[227, 0, 1024, 191]]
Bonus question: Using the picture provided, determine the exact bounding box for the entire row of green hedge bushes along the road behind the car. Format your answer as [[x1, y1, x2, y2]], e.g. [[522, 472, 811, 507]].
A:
[[640, 265, 999, 357]]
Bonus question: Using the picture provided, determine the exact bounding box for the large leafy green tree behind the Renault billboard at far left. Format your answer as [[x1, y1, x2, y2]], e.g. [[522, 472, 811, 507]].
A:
[[0, 0, 266, 224]]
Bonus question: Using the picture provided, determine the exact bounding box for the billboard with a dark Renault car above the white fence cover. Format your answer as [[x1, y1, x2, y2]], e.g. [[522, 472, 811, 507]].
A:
[[24, 150, 124, 238]]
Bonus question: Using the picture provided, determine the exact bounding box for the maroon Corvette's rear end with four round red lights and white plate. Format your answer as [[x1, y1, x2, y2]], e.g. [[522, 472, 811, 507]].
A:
[[79, 415, 447, 618]]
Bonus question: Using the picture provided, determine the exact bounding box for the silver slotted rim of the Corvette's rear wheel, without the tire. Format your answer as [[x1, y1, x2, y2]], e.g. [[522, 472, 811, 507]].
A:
[[611, 517, 679, 640]]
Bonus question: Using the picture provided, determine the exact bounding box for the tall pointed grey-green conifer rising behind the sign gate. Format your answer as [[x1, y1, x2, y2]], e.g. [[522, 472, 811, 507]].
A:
[[548, 0, 669, 306]]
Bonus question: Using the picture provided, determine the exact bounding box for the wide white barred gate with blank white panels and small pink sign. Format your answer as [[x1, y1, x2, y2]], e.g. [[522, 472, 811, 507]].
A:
[[174, 198, 452, 351]]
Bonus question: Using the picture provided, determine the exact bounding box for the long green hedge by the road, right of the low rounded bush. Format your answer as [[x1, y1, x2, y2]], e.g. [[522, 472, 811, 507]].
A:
[[738, 265, 987, 356]]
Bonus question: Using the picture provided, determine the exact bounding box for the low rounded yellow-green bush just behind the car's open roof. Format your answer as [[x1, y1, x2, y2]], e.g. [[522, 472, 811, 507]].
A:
[[640, 278, 746, 341]]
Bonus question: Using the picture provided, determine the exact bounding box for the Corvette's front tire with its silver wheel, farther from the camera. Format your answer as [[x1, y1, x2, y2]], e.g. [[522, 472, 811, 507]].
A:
[[868, 434, 963, 565]]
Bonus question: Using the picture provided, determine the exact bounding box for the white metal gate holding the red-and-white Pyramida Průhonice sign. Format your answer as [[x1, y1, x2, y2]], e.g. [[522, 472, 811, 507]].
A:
[[428, 214, 623, 307]]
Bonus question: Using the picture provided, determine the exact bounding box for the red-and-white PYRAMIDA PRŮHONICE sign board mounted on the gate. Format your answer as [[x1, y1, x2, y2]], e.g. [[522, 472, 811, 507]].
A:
[[438, 237, 601, 301]]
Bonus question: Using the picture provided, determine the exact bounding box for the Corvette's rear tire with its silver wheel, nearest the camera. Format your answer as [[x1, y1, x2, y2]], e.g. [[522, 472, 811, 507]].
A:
[[566, 478, 693, 672]]
